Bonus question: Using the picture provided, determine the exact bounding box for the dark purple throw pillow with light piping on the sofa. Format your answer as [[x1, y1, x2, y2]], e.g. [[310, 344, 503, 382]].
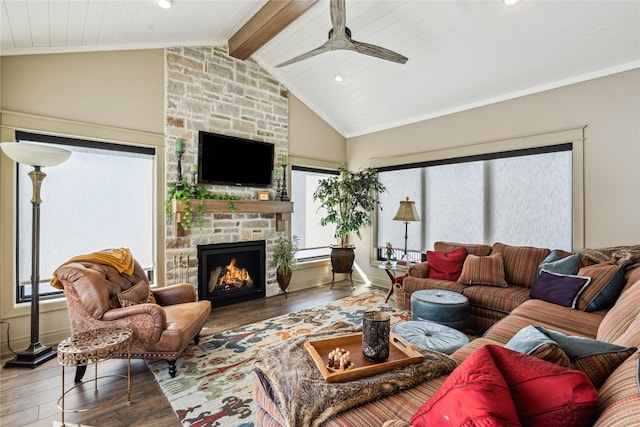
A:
[[531, 270, 591, 308]]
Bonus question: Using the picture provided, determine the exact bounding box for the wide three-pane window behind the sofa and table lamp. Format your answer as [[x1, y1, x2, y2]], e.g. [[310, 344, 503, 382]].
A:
[[377, 144, 573, 260]]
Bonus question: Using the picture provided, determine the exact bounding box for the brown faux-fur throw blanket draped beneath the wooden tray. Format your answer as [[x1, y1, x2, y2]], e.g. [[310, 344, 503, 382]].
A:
[[254, 324, 456, 427]]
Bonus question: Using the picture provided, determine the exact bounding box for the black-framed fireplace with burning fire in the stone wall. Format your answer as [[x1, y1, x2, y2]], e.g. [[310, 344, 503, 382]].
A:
[[198, 240, 266, 307]]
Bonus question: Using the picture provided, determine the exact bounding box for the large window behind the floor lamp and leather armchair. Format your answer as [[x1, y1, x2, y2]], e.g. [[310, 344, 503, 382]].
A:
[[16, 131, 155, 302]]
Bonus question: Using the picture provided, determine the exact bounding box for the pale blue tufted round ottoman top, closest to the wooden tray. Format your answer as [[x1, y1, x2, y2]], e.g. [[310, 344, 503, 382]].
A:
[[391, 320, 469, 354]]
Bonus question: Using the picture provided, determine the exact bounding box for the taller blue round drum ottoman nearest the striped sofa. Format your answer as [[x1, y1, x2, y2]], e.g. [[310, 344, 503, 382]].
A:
[[411, 289, 469, 330]]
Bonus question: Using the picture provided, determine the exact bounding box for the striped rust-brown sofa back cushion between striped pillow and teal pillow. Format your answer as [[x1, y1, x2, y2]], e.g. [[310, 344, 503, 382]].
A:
[[491, 242, 551, 288]]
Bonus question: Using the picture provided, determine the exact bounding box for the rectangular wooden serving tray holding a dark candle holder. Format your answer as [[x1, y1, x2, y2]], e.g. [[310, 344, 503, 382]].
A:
[[304, 333, 423, 383]]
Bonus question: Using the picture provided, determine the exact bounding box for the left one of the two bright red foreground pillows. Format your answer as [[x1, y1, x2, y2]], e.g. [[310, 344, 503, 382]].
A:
[[411, 347, 520, 427]]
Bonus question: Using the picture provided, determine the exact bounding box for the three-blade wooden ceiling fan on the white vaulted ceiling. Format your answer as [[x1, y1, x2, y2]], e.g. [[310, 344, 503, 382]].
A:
[[277, 0, 408, 67]]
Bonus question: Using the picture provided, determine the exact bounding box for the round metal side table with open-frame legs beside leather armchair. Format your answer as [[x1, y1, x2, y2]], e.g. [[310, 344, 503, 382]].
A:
[[58, 328, 133, 427]]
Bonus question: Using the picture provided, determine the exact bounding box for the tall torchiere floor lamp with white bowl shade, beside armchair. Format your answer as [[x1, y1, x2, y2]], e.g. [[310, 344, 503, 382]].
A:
[[0, 142, 71, 368]]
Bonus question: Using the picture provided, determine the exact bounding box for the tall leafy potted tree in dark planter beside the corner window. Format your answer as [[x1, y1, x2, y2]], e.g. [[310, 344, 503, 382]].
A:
[[313, 165, 386, 286]]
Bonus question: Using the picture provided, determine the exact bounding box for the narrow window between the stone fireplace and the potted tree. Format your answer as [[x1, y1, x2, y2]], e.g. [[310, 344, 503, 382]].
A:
[[291, 165, 337, 261]]
